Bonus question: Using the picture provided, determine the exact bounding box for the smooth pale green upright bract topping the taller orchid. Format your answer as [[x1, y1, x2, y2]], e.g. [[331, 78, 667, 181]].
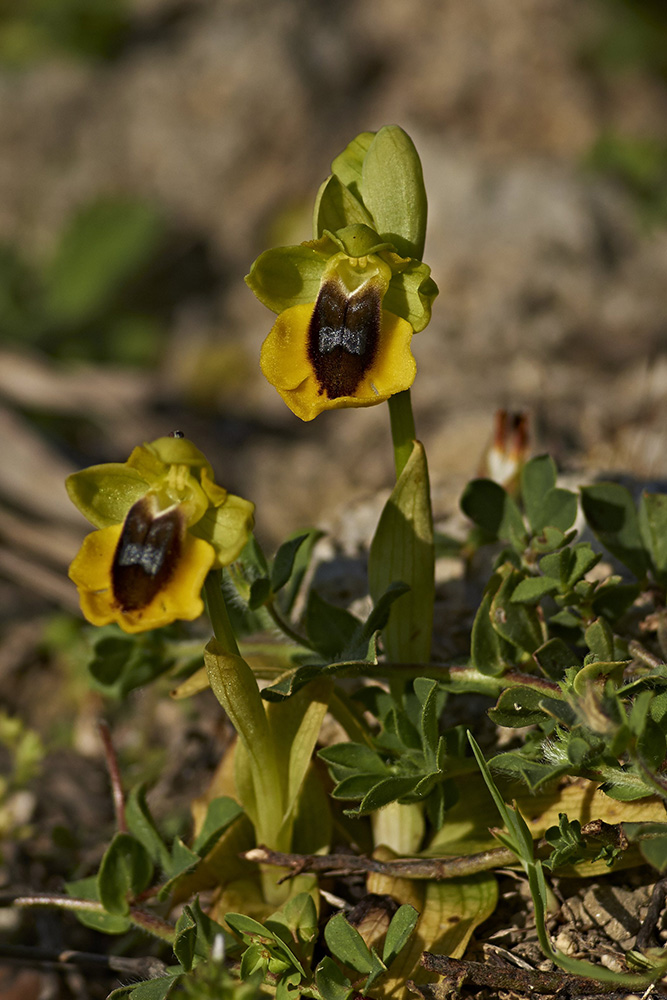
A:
[[361, 125, 427, 260]]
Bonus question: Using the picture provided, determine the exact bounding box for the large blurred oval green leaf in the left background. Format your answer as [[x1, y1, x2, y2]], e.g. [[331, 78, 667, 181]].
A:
[[44, 198, 164, 326]]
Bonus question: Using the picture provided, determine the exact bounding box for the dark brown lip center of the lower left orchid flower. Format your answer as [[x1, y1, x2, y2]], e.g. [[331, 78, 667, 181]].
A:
[[111, 496, 184, 611]]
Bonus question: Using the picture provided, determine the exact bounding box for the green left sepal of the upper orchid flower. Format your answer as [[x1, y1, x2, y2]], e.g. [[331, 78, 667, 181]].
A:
[[245, 240, 336, 313]]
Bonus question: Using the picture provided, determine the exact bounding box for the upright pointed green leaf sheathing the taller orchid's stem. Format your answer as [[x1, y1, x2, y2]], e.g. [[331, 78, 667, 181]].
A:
[[368, 441, 435, 663]]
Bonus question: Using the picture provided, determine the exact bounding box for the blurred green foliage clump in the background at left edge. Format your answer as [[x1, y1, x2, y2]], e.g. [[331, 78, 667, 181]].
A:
[[0, 198, 166, 365]]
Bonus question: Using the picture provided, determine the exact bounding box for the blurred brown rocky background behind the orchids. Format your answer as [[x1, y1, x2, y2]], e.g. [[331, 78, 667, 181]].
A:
[[0, 0, 667, 998]]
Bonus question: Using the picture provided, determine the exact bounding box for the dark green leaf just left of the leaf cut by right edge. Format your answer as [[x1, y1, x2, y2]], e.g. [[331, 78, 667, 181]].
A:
[[581, 483, 648, 579]]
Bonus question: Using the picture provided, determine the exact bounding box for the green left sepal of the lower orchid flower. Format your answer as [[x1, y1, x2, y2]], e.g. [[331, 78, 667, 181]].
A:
[[65, 462, 150, 528]]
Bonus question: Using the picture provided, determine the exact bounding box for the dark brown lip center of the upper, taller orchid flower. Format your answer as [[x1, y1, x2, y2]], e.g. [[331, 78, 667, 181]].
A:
[[308, 278, 382, 399]]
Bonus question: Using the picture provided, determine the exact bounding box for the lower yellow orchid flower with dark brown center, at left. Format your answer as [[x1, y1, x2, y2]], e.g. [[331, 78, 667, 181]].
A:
[[67, 437, 254, 632]]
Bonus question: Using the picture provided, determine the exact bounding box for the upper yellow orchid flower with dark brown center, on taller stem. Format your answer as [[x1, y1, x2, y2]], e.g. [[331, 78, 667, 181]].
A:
[[246, 225, 435, 420]]
